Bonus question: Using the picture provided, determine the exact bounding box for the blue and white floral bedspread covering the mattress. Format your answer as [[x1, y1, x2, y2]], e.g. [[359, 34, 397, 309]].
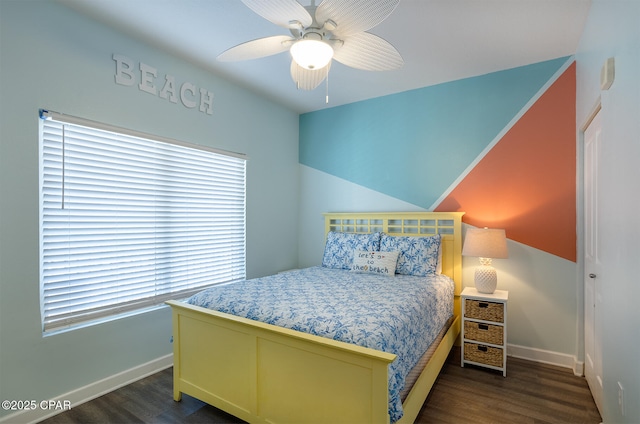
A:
[[187, 267, 453, 422]]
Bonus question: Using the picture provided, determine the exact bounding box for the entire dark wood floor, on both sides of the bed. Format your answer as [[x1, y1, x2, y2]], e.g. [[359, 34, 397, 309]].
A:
[[44, 349, 601, 424]]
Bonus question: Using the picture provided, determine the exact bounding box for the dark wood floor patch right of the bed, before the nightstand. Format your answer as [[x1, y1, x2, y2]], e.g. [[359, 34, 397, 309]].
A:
[[416, 351, 602, 424]]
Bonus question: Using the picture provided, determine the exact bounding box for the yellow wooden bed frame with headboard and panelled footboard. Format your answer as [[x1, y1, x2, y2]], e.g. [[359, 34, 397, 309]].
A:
[[167, 212, 463, 423]]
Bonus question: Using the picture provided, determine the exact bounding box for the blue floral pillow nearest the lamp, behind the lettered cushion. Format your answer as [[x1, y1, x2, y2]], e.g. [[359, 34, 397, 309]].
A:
[[380, 233, 440, 277]]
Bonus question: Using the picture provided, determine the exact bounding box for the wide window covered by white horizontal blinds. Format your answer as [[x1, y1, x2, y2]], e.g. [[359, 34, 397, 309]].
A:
[[40, 111, 246, 332]]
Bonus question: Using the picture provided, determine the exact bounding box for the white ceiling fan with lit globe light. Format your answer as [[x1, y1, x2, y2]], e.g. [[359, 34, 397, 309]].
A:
[[218, 0, 404, 90]]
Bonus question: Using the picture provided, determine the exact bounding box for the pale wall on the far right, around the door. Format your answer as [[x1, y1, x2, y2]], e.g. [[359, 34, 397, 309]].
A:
[[576, 0, 640, 423]]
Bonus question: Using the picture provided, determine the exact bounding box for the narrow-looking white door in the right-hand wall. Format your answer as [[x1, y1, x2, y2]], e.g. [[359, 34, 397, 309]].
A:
[[584, 108, 602, 415]]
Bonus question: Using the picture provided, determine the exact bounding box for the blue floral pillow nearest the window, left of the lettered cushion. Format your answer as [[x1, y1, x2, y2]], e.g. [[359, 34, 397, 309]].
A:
[[322, 231, 380, 269]]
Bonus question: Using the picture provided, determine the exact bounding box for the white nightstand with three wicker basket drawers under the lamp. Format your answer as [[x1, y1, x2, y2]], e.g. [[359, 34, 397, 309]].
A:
[[460, 287, 509, 377]]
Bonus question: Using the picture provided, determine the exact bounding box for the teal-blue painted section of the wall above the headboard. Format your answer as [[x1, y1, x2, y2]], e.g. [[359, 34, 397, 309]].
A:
[[300, 58, 567, 208]]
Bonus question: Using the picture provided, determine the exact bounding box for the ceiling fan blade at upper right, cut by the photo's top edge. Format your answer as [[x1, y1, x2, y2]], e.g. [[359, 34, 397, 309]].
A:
[[316, 0, 400, 37]]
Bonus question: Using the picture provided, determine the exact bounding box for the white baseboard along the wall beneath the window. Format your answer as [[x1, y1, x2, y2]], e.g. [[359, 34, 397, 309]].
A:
[[0, 354, 173, 424]]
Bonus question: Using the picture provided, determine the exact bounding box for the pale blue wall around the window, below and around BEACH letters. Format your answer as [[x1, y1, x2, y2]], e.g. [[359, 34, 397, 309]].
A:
[[0, 0, 298, 417]]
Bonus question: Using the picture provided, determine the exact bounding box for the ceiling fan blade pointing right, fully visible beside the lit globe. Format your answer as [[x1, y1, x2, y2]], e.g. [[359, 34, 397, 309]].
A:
[[333, 32, 404, 71]]
